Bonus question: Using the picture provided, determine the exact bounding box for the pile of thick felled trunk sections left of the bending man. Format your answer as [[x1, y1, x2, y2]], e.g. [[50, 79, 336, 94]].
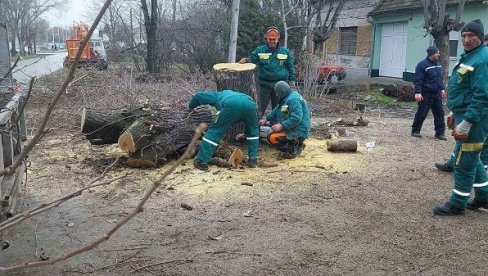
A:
[[81, 105, 212, 167]]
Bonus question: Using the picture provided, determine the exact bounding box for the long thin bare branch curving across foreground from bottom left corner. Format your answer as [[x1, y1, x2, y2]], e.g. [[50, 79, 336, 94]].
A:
[[0, 123, 207, 274]]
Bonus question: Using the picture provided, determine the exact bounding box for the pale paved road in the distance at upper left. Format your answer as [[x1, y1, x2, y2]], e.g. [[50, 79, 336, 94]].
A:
[[13, 52, 66, 83]]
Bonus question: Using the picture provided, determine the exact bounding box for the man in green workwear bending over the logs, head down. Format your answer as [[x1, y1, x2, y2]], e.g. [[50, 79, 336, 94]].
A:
[[188, 90, 259, 171]]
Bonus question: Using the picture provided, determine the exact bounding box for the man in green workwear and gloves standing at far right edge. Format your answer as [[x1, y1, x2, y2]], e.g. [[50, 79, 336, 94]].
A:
[[433, 19, 488, 216]]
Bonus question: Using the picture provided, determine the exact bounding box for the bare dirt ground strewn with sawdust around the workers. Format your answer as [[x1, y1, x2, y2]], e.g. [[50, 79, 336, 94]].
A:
[[0, 70, 488, 275]]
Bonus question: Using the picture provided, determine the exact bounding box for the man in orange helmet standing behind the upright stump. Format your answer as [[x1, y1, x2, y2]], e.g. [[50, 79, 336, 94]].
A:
[[239, 27, 296, 116]]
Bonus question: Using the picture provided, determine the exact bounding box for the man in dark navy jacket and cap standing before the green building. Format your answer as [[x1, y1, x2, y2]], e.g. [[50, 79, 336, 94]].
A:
[[412, 46, 447, 140]]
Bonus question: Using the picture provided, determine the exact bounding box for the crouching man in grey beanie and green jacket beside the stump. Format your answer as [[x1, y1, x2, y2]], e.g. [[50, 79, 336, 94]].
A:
[[259, 81, 310, 158]]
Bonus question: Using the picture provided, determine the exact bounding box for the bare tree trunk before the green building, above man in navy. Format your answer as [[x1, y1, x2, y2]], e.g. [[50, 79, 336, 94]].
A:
[[420, 0, 466, 83]]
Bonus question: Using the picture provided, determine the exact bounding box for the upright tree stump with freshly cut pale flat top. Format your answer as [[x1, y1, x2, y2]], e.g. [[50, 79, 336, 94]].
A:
[[213, 63, 259, 141]]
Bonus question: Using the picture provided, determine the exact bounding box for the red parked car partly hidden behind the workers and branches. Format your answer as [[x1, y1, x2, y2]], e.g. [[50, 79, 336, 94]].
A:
[[295, 58, 346, 84]]
